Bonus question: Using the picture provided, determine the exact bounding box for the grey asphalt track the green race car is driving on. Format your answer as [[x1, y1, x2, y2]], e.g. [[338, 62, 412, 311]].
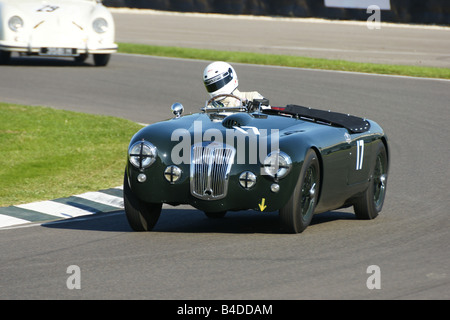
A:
[[0, 10, 450, 299]]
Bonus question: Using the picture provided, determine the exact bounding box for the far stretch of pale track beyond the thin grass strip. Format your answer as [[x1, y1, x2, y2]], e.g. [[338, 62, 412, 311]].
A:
[[113, 9, 450, 68]]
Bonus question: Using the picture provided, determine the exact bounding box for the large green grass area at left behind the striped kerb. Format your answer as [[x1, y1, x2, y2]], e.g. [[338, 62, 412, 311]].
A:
[[0, 103, 142, 207]]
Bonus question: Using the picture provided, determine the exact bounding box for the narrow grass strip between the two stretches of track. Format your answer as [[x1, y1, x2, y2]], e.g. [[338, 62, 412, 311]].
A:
[[119, 43, 450, 79]]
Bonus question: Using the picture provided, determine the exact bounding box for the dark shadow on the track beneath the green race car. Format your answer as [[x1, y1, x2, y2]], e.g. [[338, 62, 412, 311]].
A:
[[42, 208, 355, 234]]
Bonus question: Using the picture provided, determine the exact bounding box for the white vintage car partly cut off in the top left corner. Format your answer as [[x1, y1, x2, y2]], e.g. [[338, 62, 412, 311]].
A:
[[0, 0, 117, 66]]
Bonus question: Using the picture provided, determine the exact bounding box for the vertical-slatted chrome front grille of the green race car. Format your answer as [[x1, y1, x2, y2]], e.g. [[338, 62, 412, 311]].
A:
[[191, 142, 236, 200]]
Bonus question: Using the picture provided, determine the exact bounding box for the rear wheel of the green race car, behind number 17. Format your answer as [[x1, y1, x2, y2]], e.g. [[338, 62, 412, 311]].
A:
[[353, 141, 388, 220]]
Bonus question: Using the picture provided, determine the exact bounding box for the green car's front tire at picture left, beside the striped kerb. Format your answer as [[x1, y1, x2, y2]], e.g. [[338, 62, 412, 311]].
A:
[[123, 172, 162, 231]]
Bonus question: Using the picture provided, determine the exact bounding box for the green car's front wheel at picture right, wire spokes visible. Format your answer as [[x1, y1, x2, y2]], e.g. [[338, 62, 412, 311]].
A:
[[279, 149, 320, 233]]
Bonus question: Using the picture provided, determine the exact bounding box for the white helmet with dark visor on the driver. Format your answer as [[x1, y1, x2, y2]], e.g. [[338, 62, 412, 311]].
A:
[[203, 61, 239, 97]]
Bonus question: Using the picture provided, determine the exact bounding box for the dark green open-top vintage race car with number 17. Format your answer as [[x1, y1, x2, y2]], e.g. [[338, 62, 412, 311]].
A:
[[123, 95, 389, 233]]
